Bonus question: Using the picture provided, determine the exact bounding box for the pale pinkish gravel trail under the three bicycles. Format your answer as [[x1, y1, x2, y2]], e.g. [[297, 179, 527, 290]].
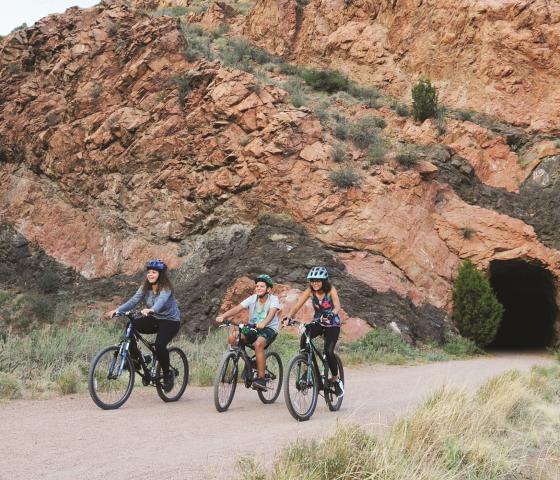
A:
[[0, 353, 553, 480]]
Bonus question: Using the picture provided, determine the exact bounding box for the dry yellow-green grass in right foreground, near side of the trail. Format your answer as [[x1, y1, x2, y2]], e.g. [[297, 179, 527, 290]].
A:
[[239, 367, 560, 480]]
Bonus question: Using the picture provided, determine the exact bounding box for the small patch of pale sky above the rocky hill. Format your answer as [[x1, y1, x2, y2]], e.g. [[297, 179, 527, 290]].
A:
[[0, 0, 100, 35]]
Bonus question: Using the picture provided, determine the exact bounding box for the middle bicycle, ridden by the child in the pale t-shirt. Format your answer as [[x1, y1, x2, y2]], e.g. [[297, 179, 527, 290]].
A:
[[214, 320, 283, 412]]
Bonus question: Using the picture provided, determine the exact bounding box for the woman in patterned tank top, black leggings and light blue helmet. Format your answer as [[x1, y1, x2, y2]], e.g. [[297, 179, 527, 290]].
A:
[[287, 267, 344, 397]]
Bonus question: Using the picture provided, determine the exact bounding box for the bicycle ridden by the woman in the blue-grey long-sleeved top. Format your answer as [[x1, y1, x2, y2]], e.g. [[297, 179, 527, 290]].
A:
[[88, 312, 189, 410]]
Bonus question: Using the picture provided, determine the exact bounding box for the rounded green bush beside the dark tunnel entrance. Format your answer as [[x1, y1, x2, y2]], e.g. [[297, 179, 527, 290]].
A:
[[453, 260, 504, 347]]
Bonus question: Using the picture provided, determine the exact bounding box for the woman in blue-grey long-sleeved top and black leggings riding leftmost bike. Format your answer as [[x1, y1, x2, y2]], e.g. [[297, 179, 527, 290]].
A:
[[109, 259, 181, 392]]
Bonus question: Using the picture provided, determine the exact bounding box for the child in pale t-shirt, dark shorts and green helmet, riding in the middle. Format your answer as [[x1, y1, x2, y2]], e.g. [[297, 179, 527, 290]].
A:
[[216, 275, 280, 390]]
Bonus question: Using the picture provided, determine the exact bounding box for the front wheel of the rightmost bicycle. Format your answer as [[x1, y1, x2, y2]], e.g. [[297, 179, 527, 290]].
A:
[[284, 354, 319, 422]]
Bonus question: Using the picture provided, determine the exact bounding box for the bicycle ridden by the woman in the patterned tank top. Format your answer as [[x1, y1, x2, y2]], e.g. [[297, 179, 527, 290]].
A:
[[284, 318, 344, 422]]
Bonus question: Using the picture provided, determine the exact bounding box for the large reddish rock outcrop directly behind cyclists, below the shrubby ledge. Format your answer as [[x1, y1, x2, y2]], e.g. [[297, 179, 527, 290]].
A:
[[0, 4, 560, 340]]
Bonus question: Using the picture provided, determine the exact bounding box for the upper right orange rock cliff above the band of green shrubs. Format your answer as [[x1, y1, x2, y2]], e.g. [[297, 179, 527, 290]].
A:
[[245, 0, 560, 131]]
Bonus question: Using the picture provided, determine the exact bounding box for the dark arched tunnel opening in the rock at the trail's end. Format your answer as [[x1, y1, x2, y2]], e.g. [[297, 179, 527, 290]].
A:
[[489, 260, 558, 349]]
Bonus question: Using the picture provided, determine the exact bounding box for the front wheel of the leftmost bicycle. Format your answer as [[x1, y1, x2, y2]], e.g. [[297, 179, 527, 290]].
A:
[[88, 346, 134, 410]]
